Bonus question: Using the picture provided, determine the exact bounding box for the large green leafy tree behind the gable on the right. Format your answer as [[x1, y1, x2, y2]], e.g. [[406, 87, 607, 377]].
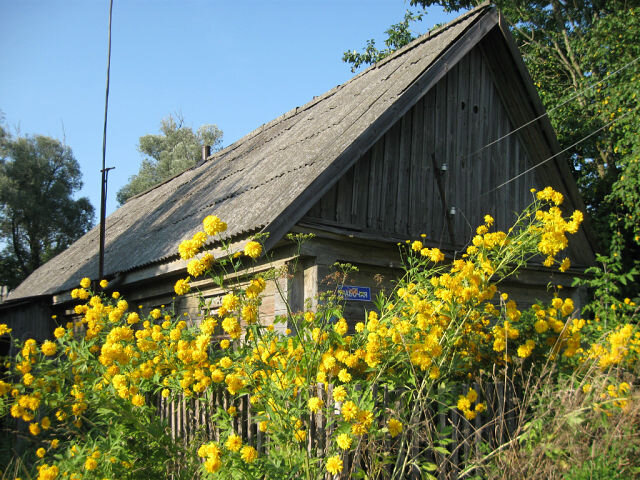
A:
[[344, 0, 640, 300]]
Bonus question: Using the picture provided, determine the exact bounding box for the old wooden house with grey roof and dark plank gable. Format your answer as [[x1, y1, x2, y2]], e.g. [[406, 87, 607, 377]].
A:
[[0, 6, 594, 337]]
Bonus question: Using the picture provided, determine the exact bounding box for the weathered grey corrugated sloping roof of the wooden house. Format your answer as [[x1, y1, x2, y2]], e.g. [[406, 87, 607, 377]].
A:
[[9, 6, 497, 299]]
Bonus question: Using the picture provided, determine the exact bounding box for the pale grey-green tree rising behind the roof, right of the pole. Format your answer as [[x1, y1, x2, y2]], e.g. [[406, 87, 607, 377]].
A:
[[116, 115, 222, 205]]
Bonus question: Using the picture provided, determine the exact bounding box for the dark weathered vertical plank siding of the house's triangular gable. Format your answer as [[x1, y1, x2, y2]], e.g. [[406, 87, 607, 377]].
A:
[[302, 47, 543, 248]]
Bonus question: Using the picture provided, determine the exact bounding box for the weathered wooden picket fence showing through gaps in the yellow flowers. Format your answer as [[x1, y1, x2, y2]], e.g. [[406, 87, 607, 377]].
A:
[[155, 383, 520, 480]]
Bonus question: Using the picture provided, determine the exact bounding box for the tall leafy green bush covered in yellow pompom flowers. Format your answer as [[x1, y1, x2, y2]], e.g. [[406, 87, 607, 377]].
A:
[[0, 188, 639, 479]]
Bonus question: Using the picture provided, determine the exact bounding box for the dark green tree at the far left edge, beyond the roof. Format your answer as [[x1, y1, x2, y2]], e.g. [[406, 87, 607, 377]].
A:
[[0, 130, 94, 288]]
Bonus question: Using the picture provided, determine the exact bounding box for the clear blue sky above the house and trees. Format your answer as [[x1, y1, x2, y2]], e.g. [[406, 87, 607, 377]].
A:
[[0, 0, 455, 214]]
